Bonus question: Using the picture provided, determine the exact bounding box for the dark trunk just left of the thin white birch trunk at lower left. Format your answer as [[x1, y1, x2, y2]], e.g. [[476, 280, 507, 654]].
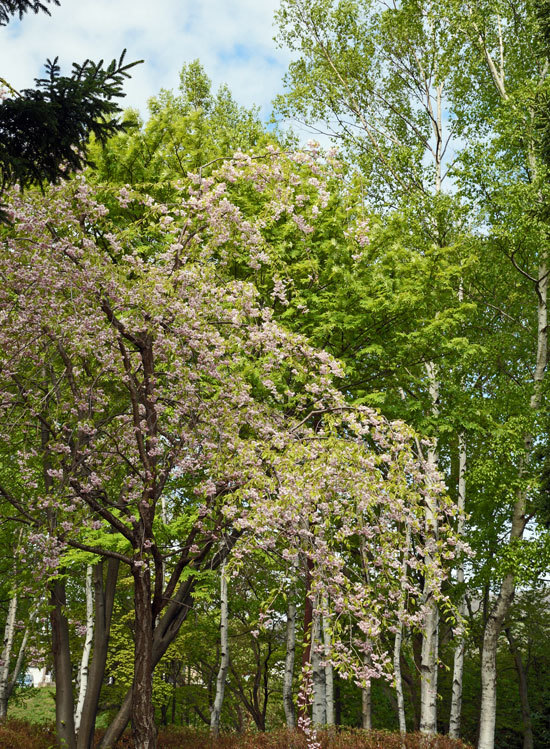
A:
[[49, 578, 76, 749]]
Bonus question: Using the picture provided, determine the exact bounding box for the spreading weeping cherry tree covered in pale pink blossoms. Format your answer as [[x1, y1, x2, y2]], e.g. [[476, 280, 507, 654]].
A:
[[0, 149, 466, 749]]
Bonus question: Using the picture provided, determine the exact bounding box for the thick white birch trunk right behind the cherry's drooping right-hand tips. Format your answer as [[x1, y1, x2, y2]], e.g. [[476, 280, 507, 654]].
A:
[[420, 362, 439, 734]]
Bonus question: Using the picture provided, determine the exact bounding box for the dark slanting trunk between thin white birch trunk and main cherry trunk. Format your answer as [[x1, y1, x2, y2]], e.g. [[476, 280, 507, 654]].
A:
[[76, 559, 120, 749]]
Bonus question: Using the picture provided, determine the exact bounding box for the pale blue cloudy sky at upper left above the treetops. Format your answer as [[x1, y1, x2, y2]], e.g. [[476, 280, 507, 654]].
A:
[[0, 0, 289, 117]]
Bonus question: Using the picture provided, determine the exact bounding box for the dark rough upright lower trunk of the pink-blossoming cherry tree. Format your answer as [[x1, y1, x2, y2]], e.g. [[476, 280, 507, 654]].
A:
[[132, 565, 157, 749]]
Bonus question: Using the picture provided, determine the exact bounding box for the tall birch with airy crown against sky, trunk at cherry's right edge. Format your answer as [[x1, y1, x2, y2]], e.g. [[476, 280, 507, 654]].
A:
[[277, 0, 474, 733]]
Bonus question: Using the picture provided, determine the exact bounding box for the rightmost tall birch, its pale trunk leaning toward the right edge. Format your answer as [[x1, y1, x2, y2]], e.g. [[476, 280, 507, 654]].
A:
[[444, 3, 548, 749]]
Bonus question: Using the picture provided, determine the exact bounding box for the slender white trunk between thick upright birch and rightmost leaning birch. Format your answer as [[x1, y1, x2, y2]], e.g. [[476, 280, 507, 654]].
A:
[[449, 432, 466, 739]]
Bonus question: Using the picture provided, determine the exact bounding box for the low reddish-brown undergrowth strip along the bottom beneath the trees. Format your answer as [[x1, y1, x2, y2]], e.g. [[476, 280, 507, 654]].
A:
[[0, 718, 469, 749]]
